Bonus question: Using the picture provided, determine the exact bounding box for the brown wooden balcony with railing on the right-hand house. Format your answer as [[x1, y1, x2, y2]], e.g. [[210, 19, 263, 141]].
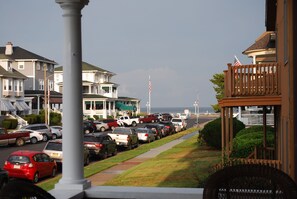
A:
[[219, 63, 281, 107]]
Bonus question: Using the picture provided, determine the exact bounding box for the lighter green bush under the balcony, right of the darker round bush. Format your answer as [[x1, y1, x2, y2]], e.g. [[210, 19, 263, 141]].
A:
[[231, 126, 274, 158]]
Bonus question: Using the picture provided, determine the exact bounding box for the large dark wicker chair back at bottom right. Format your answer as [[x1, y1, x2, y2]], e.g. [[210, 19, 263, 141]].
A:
[[203, 164, 297, 199]]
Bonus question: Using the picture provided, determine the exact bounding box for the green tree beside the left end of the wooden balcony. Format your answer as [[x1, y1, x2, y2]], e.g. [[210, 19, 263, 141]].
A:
[[210, 73, 225, 112]]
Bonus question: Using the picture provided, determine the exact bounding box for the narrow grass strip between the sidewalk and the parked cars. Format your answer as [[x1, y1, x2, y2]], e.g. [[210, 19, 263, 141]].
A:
[[37, 127, 199, 191]]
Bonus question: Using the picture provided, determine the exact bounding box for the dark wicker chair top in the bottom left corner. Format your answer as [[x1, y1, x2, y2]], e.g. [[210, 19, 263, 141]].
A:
[[0, 180, 55, 199]]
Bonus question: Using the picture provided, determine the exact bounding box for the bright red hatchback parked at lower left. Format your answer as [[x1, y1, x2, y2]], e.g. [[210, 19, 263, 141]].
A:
[[3, 150, 57, 183]]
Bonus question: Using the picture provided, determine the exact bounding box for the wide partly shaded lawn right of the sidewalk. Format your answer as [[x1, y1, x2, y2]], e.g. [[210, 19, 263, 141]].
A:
[[104, 133, 221, 188]]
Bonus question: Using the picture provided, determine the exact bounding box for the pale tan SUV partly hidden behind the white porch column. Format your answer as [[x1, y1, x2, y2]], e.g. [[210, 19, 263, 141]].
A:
[[42, 139, 90, 165]]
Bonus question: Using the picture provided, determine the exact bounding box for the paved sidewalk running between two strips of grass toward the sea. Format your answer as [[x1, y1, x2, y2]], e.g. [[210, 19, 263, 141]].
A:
[[88, 131, 198, 186]]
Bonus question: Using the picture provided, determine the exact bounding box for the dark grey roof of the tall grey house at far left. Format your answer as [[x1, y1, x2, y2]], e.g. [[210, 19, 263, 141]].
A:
[[0, 46, 57, 65]]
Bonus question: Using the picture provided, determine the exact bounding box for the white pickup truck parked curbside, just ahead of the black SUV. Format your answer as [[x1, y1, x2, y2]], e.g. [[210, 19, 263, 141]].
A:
[[108, 127, 139, 149]]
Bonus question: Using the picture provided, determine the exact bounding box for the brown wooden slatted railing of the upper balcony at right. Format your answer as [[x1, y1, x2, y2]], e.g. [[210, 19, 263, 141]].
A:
[[224, 63, 281, 97]]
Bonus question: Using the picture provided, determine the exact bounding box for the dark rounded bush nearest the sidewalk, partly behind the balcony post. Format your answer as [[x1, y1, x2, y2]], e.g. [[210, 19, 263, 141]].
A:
[[200, 118, 245, 149]]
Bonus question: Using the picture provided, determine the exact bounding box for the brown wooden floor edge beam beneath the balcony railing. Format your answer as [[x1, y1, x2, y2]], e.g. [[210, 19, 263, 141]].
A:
[[219, 96, 282, 107]]
